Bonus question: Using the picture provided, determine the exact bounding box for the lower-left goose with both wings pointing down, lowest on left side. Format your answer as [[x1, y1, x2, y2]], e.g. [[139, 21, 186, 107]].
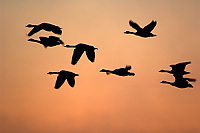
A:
[[47, 70, 79, 89]]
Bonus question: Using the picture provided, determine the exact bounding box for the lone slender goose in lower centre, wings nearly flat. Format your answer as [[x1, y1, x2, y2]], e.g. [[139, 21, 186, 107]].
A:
[[100, 66, 135, 76]]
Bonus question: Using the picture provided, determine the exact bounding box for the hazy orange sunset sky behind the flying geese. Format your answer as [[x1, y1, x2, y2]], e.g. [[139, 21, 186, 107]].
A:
[[0, 0, 200, 133]]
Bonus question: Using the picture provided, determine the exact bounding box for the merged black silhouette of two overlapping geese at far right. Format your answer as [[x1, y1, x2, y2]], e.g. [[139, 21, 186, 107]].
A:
[[159, 61, 196, 88]]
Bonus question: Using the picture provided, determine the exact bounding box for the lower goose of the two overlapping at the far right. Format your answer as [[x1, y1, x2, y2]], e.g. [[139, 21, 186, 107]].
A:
[[160, 75, 196, 88]]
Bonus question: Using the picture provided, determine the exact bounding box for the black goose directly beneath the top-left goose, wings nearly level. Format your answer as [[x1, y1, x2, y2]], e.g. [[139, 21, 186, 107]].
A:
[[28, 36, 64, 48]]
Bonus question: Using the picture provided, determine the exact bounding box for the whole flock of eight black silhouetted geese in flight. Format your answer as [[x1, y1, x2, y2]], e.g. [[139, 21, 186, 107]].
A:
[[26, 20, 196, 89]]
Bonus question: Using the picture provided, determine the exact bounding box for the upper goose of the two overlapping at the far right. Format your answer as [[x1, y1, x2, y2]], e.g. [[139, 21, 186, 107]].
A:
[[159, 61, 191, 75]]
